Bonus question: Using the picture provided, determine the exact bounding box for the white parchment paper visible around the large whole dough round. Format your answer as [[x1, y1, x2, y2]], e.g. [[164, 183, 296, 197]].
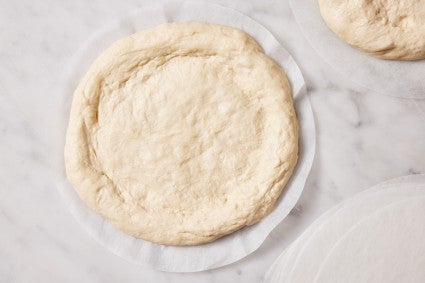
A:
[[58, 1, 315, 272]]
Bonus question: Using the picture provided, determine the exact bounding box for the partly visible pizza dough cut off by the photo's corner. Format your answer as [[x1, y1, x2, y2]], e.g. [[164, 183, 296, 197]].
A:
[[318, 0, 425, 60]]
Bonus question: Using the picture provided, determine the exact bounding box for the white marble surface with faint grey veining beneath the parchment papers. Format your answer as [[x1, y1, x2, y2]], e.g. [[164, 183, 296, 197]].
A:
[[0, 0, 425, 283]]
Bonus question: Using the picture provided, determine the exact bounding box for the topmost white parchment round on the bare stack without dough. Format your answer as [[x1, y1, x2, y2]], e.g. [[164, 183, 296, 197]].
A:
[[310, 196, 425, 283]]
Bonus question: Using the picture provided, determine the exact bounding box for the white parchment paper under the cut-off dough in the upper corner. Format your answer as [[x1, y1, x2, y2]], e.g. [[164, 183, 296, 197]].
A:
[[289, 0, 425, 98]]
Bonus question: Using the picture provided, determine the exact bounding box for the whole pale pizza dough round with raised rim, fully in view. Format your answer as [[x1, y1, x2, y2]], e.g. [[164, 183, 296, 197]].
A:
[[65, 23, 298, 245]]
